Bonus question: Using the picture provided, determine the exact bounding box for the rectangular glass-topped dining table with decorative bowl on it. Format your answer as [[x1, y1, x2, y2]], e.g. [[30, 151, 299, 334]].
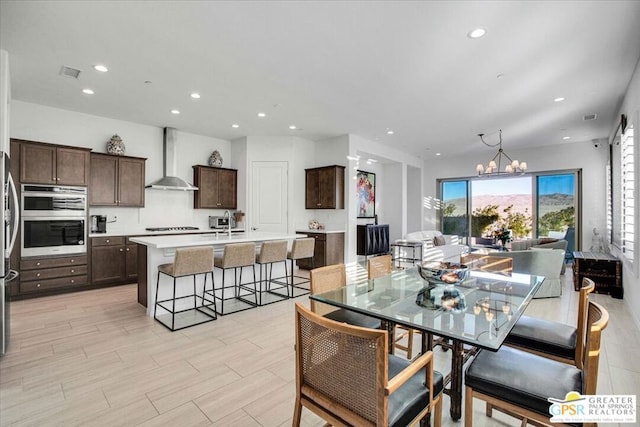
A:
[[310, 267, 544, 421]]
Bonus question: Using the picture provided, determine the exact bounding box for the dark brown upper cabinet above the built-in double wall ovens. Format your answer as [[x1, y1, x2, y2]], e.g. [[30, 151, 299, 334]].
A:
[[20, 141, 91, 185]]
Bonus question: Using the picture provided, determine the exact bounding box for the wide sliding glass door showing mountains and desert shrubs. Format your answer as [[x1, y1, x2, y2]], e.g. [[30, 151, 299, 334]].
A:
[[438, 170, 580, 251]]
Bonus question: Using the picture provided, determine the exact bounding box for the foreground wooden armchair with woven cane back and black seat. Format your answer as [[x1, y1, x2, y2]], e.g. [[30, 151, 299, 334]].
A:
[[292, 303, 443, 427]]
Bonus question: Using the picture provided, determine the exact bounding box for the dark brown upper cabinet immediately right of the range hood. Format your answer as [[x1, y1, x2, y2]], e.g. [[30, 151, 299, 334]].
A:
[[193, 165, 238, 209]]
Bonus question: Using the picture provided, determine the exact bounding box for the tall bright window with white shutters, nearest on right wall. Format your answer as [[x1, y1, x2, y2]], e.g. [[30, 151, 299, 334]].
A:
[[620, 126, 636, 262]]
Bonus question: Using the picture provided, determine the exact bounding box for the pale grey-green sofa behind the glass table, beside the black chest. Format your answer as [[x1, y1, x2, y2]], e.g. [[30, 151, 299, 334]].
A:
[[488, 247, 564, 298]]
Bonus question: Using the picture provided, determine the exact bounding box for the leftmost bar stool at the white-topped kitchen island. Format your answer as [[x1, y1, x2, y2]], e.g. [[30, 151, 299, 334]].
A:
[[153, 246, 217, 331]]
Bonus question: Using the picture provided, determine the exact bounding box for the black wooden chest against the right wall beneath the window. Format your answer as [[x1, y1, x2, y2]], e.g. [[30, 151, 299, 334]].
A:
[[573, 251, 624, 298]]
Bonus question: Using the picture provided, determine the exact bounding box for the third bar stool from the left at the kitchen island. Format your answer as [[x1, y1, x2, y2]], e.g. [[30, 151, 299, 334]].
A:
[[256, 240, 291, 305]]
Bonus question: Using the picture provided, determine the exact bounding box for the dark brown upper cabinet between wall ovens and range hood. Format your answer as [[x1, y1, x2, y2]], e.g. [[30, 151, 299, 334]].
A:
[[89, 153, 146, 207]]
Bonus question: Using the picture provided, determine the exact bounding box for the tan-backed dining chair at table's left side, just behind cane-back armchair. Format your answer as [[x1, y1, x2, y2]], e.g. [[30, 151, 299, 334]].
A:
[[309, 264, 382, 329]]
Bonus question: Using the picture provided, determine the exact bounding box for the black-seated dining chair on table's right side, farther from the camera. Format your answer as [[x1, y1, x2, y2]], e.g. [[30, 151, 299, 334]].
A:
[[505, 277, 595, 368]]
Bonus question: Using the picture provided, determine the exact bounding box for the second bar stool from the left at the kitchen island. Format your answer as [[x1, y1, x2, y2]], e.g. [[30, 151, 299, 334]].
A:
[[208, 242, 258, 316]]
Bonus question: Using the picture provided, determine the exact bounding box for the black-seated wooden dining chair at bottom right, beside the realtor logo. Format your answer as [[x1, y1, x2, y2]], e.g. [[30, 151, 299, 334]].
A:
[[464, 301, 609, 427]]
